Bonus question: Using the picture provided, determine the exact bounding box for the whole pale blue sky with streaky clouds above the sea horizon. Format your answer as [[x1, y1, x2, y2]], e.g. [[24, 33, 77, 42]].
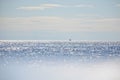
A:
[[0, 0, 120, 40]]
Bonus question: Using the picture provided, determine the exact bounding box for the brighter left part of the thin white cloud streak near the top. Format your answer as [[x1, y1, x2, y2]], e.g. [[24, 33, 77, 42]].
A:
[[17, 4, 63, 10]]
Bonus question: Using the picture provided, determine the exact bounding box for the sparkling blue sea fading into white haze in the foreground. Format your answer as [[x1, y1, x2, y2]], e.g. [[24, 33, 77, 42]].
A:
[[0, 41, 120, 80]]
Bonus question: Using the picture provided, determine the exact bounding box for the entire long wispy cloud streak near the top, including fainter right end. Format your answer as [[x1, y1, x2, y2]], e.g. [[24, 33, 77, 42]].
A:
[[17, 4, 95, 10]]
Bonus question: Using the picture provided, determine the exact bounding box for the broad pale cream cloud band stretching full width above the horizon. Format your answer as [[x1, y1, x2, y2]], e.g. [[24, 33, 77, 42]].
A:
[[0, 16, 120, 32]]
